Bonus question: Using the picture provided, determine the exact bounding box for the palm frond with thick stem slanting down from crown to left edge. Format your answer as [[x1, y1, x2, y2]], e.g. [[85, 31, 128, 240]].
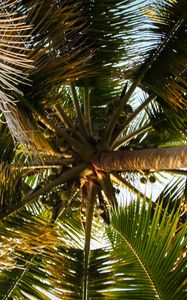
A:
[[0, 164, 88, 220]]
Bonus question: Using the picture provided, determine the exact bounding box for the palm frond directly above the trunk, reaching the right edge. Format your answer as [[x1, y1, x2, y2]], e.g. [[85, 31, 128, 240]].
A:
[[111, 92, 186, 149]]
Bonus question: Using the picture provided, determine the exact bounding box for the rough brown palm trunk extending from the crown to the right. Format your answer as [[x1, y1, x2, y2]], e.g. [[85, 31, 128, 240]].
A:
[[92, 146, 187, 172]]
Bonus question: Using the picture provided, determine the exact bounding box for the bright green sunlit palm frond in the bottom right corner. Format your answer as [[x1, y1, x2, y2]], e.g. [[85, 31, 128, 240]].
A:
[[108, 201, 186, 299]]
